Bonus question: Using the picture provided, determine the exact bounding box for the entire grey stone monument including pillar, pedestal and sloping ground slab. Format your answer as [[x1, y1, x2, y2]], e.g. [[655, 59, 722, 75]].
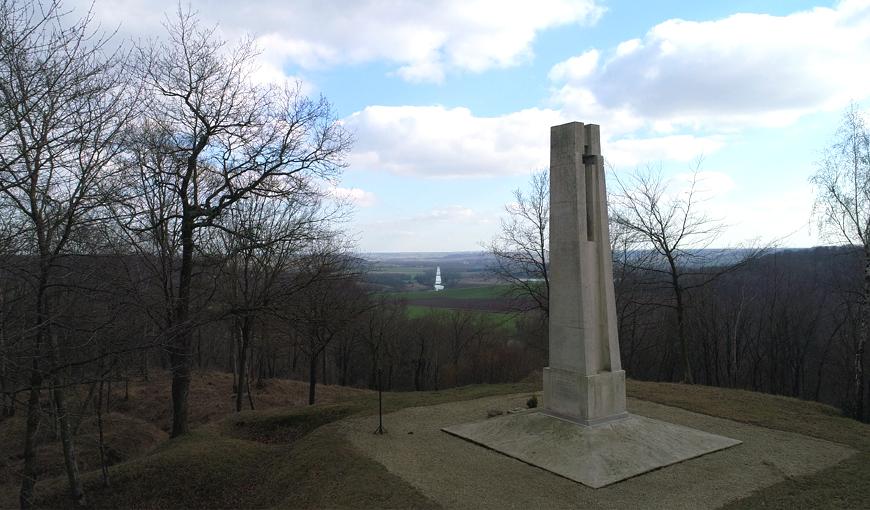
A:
[[443, 122, 740, 488]]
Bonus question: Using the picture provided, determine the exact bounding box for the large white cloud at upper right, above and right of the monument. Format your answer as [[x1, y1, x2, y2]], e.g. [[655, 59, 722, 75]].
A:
[[551, 0, 870, 131]]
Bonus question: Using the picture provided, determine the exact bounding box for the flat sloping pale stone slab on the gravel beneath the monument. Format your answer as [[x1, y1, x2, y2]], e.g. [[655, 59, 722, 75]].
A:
[[442, 411, 740, 489]]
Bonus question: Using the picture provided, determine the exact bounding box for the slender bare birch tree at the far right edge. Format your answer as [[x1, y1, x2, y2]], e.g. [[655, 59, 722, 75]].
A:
[[810, 104, 870, 419]]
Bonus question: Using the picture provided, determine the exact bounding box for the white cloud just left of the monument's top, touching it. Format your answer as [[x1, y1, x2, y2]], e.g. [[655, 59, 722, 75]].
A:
[[345, 106, 564, 177]]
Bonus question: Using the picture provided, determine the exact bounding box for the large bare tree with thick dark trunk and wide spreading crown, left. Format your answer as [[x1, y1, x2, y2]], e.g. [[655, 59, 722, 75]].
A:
[[117, 9, 351, 436]]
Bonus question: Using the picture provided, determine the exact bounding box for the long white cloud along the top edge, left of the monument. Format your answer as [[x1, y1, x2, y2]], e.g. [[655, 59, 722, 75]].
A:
[[73, 0, 603, 82]]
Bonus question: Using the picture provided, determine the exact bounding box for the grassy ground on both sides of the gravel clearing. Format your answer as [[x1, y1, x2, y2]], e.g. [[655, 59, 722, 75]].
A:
[[0, 381, 870, 508]]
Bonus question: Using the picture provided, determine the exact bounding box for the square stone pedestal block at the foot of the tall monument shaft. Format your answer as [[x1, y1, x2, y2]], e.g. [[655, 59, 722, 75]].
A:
[[543, 367, 628, 425]]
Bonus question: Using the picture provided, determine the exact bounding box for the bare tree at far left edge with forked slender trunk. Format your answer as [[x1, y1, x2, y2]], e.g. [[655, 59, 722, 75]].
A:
[[0, 0, 130, 507]]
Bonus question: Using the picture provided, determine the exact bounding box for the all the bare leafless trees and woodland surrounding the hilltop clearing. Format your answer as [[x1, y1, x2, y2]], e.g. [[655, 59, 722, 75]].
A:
[[0, 1, 870, 507]]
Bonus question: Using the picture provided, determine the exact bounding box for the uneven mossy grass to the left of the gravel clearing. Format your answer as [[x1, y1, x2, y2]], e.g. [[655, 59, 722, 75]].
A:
[[27, 384, 535, 508]]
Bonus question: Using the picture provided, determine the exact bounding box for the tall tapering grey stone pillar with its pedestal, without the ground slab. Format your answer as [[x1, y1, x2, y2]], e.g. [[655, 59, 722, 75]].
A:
[[544, 122, 628, 425]]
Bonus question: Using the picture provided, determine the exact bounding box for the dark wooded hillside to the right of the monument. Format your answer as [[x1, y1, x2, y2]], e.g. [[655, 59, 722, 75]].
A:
[[617, 248, 867, 420]]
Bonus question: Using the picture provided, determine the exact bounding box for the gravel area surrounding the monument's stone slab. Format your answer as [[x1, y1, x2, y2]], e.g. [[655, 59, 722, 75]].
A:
[[332, 394, 855, 509]]
